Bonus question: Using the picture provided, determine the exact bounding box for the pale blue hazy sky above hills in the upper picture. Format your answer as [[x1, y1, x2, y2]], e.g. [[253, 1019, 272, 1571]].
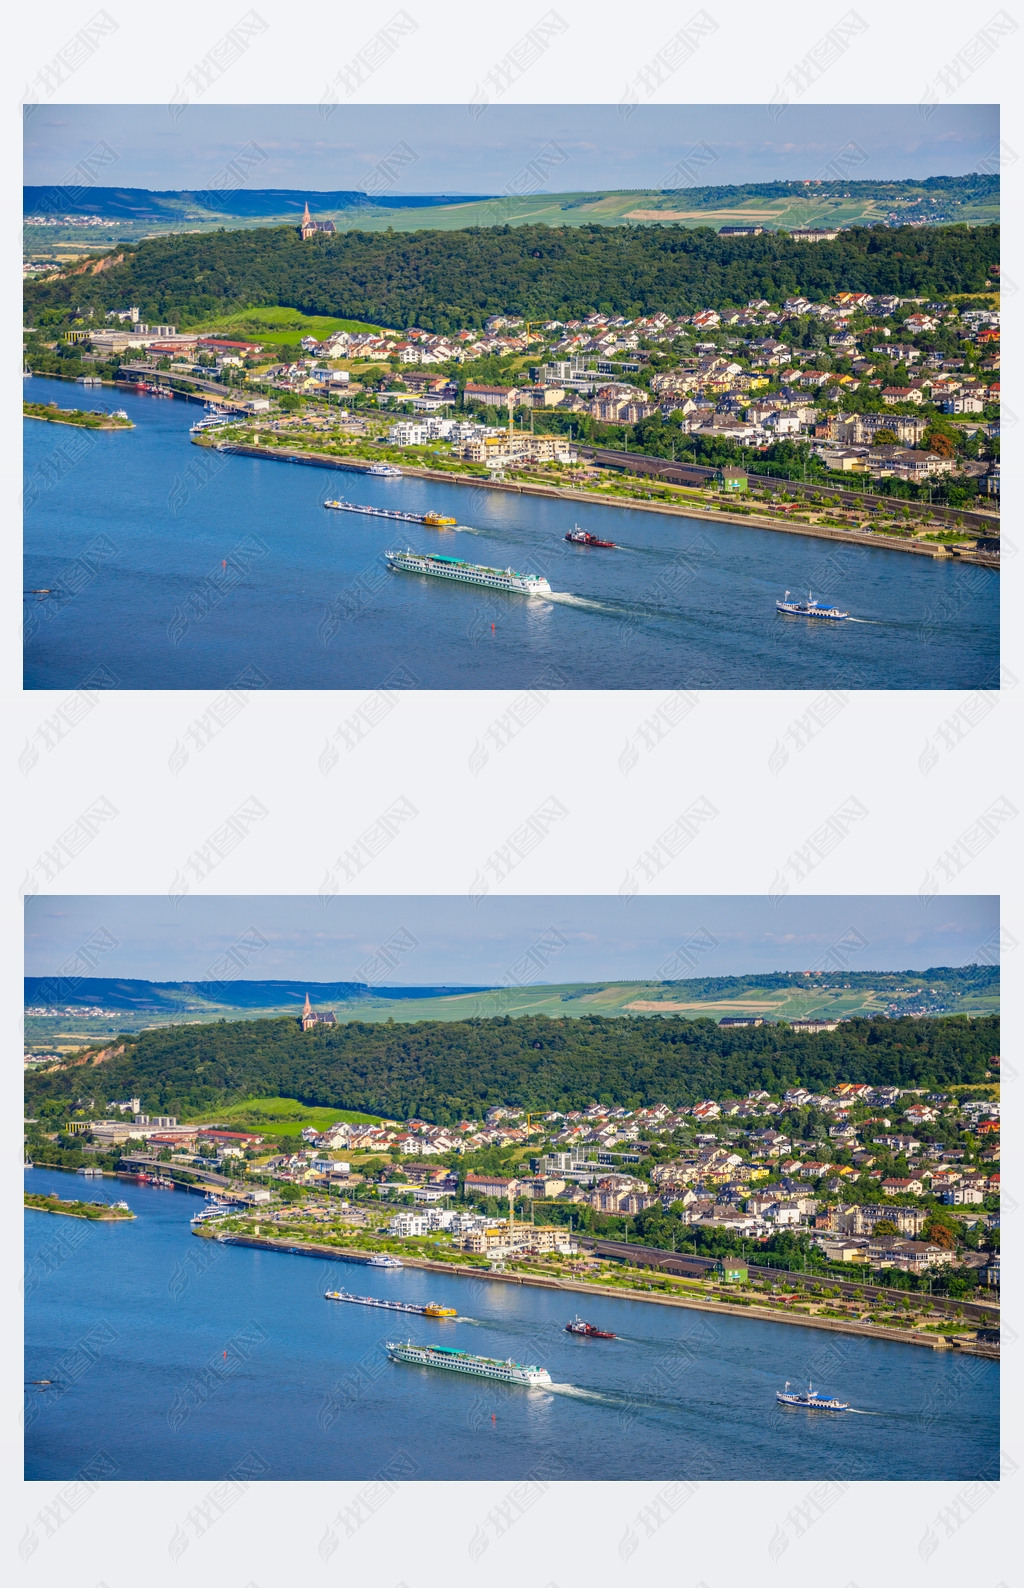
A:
[[24, 105, 999, 194]]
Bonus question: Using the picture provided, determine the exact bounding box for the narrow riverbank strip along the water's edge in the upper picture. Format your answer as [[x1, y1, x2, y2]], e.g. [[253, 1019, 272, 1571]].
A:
[[203, 437, 1000, 569]]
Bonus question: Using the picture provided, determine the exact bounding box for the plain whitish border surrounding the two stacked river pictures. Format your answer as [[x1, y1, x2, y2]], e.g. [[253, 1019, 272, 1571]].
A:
[[5, 0, 1024, 1588]]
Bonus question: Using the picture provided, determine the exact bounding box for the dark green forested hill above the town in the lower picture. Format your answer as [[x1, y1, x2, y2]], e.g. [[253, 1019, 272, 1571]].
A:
[[25, 1016, 999, 1124]]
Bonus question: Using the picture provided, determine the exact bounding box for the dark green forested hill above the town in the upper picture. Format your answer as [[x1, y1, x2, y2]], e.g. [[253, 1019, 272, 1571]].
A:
[[25, 225, 999, 332]]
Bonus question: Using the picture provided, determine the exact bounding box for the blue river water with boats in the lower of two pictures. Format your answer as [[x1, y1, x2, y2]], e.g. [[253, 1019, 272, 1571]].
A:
[[25, 1169, 999, 1482]]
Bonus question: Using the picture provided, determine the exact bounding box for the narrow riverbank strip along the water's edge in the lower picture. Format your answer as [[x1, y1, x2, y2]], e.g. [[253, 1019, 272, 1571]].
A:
[[203, 1226, 999, 1359]]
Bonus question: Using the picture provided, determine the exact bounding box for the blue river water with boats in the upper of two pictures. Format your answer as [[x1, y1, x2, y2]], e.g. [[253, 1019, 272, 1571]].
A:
[[25, 376, 999, 689]]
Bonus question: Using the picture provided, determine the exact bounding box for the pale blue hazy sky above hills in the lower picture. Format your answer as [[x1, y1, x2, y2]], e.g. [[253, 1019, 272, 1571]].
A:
[[25, 894, 999, 986]]
